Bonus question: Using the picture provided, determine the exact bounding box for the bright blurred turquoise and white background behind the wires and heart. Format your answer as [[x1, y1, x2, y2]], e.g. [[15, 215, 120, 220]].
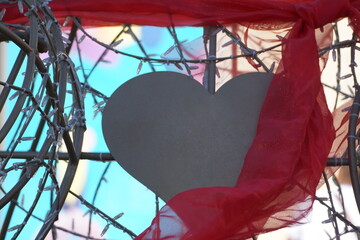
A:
[[0, 13, 360, 240]]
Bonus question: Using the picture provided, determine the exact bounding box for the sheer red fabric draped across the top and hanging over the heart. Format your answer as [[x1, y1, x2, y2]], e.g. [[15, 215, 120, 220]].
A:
[[0, 0, 360, 240]]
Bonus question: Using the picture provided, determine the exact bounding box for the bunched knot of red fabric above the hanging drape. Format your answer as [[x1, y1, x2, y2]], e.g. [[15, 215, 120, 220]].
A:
[[295, 0, 350, 29]]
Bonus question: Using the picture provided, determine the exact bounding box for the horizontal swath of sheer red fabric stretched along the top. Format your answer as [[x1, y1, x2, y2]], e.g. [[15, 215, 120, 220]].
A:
[[0, 0, 352, 29]]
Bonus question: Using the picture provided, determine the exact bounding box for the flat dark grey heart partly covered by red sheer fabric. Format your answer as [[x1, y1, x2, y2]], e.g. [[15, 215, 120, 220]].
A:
[[102, 72, 273, 201]]
